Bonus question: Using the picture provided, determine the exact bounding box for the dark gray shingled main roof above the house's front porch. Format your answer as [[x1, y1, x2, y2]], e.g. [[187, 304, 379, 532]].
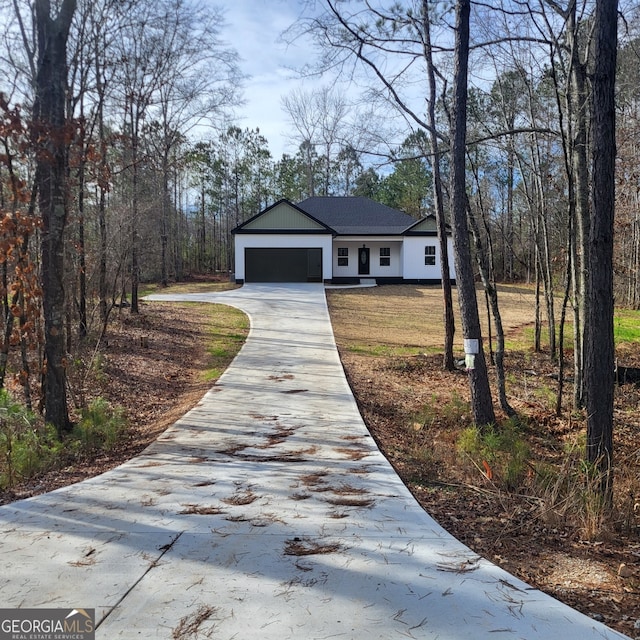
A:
[[297, 196, 416, 235]]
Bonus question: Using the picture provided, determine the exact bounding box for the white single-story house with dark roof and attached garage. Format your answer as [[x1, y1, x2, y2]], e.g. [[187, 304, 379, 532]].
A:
[[232, 197, 455, 284]]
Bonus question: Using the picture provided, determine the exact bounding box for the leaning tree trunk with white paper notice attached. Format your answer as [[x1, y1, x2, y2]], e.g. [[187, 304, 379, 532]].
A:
[[451, 0, 495, 426]]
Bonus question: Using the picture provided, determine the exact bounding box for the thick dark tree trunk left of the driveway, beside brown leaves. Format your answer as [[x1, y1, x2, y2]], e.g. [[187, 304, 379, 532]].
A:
[[33, 0, 76, 434]]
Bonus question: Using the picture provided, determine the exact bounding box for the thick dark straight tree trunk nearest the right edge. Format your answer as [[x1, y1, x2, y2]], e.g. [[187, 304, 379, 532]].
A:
[[584, 0, 618, 503]]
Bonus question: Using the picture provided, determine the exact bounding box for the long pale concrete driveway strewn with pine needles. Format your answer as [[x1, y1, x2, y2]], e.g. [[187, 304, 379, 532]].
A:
[[0, 285, 625, 640]]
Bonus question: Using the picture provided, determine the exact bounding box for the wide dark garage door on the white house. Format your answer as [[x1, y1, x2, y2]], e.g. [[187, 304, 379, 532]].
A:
[[244, 247, 322, 282]]
